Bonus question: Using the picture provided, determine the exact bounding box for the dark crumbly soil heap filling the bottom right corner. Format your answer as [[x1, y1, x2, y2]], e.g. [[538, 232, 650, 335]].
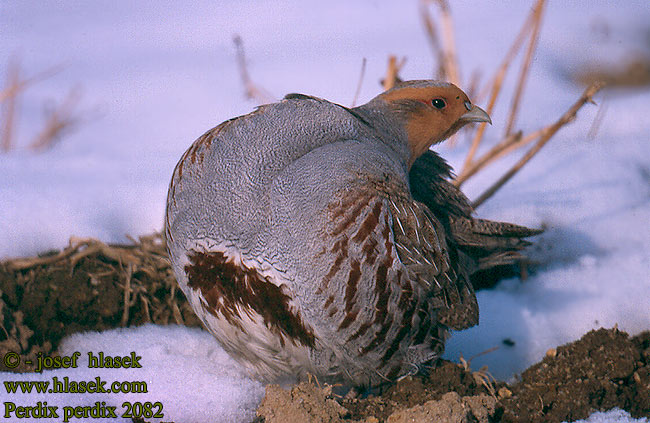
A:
[[502, 329, 650, 422]]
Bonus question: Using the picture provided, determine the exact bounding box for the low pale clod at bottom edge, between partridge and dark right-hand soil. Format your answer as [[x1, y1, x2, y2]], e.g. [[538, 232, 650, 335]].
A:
[[387, 392, 496, 423]]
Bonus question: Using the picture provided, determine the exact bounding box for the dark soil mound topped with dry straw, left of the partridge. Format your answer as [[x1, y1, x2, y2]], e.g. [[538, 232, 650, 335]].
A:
[[0, 235, 201, 371]]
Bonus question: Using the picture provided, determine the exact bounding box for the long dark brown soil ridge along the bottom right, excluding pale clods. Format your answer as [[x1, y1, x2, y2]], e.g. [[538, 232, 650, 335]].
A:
[[332, 329, 650, 423]]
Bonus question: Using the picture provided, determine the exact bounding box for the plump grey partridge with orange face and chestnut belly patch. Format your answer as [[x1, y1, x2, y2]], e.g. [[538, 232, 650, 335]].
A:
[[165, 81, 538, 385]]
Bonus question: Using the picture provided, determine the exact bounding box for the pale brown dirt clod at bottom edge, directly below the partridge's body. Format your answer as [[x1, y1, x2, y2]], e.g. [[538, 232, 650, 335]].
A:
[[257, 382, 347, 423]]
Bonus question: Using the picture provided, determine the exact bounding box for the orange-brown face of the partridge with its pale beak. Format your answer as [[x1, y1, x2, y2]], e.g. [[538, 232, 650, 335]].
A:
[[381, 84, 490, 164]]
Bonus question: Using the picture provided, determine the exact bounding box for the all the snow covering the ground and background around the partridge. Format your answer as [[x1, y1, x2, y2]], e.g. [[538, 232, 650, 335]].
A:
[[0, 0, 650, 422]]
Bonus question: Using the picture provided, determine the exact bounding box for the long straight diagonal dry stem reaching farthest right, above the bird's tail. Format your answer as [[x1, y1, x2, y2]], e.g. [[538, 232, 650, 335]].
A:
[[472, 82, 604, 208]]
